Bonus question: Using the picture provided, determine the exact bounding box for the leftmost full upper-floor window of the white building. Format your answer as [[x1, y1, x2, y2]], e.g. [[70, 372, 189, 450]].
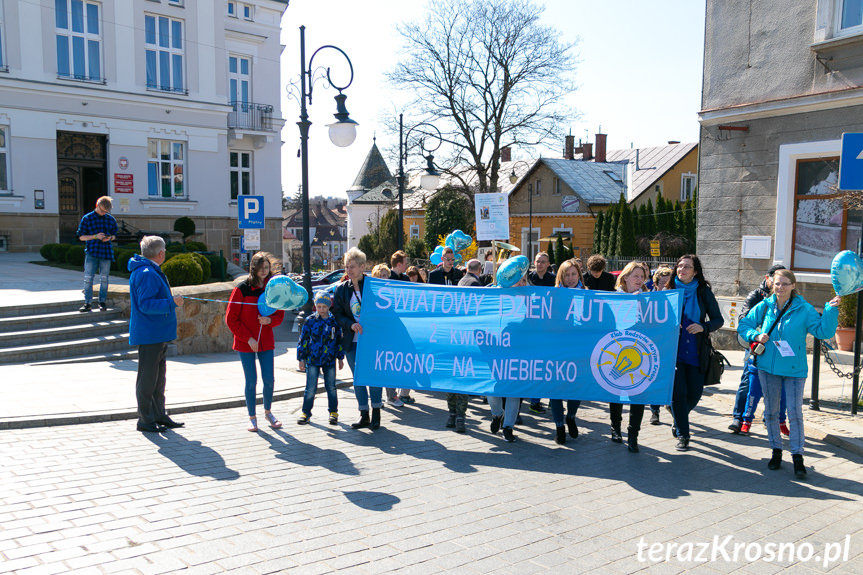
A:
[[54, 0, 103, 82]]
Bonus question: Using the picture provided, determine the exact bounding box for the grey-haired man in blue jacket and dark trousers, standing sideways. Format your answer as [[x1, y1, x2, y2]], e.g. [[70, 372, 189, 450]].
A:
[[129, 236, 184, 433]]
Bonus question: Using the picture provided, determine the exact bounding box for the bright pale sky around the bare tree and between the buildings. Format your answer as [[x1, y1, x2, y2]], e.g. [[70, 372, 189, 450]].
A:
[[282, 0, 705, 202]]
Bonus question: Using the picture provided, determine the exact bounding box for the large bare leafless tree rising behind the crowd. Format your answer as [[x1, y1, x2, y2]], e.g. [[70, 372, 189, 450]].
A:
[[387, 0, 576, 193]]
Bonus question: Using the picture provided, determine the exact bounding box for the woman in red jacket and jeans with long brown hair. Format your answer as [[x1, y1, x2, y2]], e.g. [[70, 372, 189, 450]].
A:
[[225, 252, 285, 431]]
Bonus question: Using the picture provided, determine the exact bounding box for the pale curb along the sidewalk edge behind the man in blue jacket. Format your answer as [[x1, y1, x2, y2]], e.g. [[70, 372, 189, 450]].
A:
[[0, 380, 353, 430]]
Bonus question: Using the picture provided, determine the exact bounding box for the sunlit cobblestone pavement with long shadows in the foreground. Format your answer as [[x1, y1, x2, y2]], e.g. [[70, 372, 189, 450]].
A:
[[0, 391, 863, 575]]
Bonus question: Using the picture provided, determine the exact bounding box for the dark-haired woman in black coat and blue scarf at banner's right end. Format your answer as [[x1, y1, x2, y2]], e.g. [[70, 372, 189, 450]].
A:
[[669, 254, 725, 451]]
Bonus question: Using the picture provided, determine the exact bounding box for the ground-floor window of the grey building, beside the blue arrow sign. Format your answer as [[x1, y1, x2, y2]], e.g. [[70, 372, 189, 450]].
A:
[[791, 157, 863, 272]]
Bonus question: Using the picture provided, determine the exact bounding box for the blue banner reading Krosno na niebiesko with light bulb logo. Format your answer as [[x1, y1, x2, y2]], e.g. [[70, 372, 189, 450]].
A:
[[354, 278, 683, 405]]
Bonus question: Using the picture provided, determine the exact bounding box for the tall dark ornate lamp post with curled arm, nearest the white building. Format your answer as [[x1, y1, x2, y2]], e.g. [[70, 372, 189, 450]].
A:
[[288, 26, 358, 311]]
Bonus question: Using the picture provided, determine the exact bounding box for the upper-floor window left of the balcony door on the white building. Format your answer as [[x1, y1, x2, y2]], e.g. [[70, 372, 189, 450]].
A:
[[145, 14, 186, 93]]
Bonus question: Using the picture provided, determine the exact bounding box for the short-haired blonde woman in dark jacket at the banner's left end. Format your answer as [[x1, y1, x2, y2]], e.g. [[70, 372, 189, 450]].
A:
[[332, 248, 383, 430]]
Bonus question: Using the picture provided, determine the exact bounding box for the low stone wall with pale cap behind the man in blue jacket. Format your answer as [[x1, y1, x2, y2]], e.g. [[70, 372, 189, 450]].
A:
[[108, 280, 242, 355]]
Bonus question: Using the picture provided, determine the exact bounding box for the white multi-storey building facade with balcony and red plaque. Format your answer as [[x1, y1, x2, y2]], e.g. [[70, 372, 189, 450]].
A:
[[0, 0, 288, 263]]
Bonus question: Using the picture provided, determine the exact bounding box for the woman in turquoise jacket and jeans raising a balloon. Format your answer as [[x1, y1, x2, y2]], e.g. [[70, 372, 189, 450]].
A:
[[737, 270, 839, 479]]
